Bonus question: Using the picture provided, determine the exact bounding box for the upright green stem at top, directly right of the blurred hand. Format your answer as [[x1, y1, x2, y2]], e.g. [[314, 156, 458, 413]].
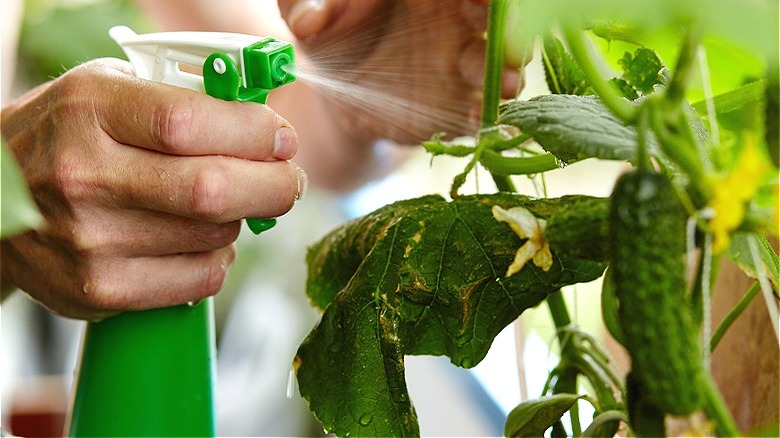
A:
[[482, 0, 508, 129]]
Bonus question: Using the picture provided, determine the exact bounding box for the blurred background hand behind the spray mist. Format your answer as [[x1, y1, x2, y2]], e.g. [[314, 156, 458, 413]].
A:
[[279, 0, 520, 142]]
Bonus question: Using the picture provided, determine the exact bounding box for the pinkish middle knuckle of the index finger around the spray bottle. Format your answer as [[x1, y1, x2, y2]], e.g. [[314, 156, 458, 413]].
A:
[[151, 96, 196, 153]]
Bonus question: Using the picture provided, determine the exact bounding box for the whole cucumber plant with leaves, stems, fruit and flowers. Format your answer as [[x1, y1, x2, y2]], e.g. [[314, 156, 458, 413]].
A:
[[294, 0, 778, 436]]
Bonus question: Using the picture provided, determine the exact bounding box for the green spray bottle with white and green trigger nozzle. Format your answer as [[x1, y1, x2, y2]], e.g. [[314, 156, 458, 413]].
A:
[[67, 26, 295, 436]]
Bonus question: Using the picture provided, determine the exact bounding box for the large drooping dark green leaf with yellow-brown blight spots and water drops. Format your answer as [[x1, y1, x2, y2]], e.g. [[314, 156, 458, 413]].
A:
[[296, 194, 604, 436]]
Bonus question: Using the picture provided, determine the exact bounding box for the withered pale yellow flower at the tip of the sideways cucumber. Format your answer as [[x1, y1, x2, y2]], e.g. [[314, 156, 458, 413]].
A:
[[492, 205, 552, 277]]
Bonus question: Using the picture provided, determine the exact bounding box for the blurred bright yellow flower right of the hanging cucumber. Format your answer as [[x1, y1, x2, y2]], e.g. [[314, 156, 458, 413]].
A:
[[709, 134, 769, 254]]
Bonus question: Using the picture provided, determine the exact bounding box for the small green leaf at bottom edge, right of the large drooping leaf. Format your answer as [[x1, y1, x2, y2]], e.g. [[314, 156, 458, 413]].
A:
[[504, 394, 582, 437]]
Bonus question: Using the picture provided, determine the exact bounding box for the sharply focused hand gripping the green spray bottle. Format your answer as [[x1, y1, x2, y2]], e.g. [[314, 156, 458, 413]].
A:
[[2, 59, 305, 320]]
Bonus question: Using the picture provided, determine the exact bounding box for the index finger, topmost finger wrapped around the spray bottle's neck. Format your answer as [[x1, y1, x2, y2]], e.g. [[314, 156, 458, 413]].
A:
[[95, 62, 298, 161]]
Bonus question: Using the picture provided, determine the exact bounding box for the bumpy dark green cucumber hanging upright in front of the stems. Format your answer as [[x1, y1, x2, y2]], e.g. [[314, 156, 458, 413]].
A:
[[609, 169, 704, 415]]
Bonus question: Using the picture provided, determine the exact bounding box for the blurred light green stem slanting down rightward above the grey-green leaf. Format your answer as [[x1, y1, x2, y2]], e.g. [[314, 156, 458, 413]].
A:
[[563, 23, 636, 122]]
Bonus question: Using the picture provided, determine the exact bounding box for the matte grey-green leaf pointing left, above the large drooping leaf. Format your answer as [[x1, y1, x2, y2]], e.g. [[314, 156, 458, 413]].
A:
[[499, 95, 659, 163]]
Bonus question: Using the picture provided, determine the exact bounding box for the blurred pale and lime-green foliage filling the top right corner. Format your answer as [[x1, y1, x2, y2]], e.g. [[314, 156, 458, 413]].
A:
[[508, 0, 778, 102]]
